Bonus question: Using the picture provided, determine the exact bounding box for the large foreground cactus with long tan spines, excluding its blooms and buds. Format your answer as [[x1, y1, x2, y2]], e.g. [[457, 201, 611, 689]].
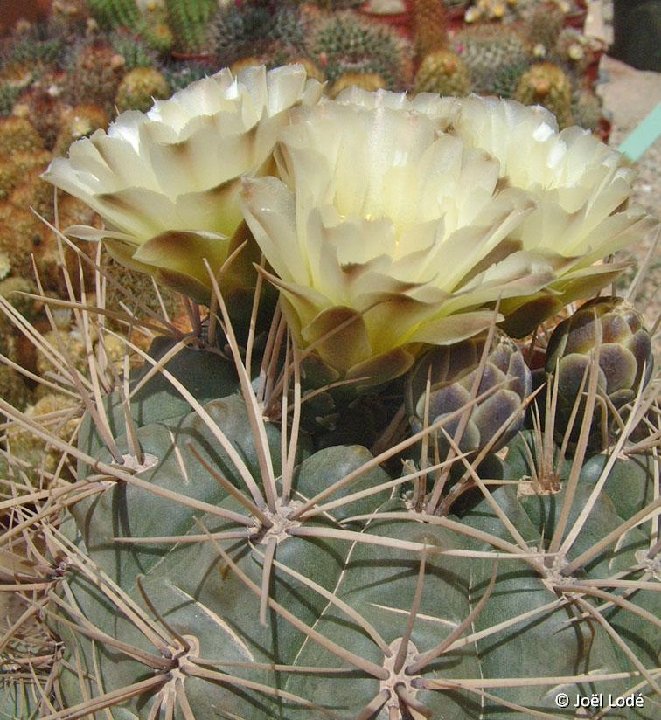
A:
[[0, 262, 661, 720]]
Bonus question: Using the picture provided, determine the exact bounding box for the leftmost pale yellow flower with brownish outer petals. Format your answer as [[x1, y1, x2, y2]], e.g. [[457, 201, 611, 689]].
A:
[[44, 66, 321, 301]]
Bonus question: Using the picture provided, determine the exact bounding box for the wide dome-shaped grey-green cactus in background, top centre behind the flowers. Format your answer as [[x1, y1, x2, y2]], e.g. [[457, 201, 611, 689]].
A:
[[308, 11, 412, 90]]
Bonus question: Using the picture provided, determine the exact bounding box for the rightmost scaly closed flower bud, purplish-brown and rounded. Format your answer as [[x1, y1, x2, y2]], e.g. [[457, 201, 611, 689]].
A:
[[546, 297, 654, 450]]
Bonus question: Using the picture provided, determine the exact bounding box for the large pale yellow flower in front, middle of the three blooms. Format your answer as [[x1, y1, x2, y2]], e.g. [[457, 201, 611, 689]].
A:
[[243, 98, 554, 382]]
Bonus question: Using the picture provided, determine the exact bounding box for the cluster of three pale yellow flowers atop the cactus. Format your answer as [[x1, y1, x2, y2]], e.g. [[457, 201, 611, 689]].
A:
[[45, 66, 653, 382]]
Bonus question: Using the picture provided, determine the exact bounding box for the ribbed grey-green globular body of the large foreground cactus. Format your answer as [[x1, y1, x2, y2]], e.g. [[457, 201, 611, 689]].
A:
[[43, 332, 658, 720]]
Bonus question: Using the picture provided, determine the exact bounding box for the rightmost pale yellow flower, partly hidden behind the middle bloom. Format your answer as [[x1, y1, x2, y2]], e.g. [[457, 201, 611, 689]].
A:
[[440, 96, 658, 335]]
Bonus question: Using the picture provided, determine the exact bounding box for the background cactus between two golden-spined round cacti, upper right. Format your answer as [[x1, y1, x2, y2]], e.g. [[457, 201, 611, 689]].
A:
[[452, 25, 532, 98]]
